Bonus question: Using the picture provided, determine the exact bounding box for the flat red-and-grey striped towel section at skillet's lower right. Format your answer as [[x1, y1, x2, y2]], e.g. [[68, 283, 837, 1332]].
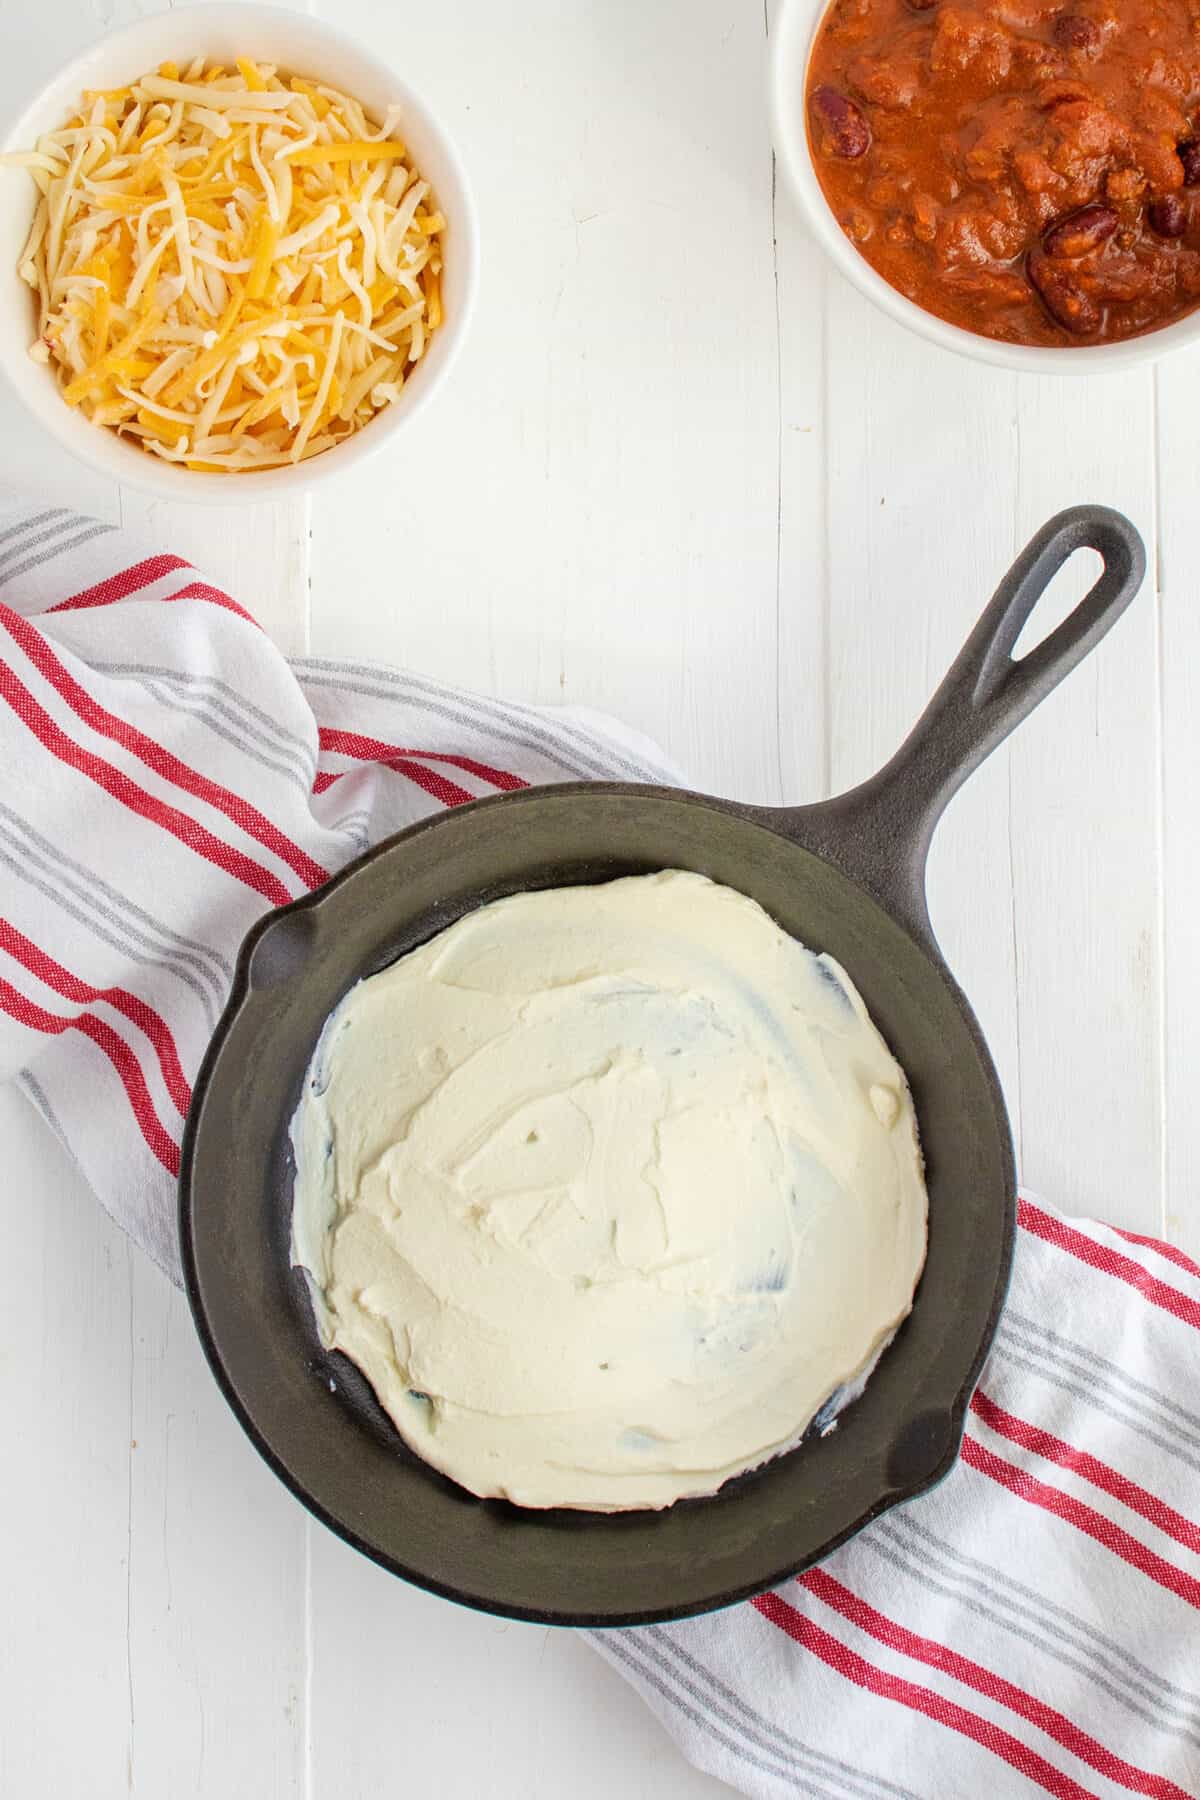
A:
[[592, 1197, 1200, 1800]]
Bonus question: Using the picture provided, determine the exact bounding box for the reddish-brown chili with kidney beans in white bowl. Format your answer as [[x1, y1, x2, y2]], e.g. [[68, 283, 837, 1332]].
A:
[[808, 0, 1200, 346]]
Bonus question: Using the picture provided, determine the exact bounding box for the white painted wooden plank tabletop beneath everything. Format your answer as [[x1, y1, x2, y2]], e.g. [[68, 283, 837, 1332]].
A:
[[0, 0, 1200, 1800]]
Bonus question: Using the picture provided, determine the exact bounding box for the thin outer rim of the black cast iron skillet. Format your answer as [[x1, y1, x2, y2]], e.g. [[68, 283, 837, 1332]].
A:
[[176, 781, 1016, 1629]]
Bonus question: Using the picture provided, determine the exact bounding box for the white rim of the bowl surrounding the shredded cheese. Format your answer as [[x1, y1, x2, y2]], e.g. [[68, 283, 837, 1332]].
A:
[[0, 0, 479, 504]]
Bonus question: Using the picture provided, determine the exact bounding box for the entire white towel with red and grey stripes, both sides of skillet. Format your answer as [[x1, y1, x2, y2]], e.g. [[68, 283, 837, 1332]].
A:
[[0, 504, 1200, 1800]]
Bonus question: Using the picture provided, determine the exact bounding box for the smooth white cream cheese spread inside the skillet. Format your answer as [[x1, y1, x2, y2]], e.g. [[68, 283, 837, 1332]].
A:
[[291, 871, 927, 1510]]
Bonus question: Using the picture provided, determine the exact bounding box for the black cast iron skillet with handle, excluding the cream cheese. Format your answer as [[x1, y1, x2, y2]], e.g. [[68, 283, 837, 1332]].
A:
[[180, 506, 1144, 1625]]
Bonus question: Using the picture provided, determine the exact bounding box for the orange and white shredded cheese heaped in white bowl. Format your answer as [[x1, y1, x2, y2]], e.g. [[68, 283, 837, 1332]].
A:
[[0, 58, 446, 472]]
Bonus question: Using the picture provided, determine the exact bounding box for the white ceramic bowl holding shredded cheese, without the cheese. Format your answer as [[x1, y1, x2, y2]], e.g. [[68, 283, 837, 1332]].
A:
[[0, 0, 479, 500]]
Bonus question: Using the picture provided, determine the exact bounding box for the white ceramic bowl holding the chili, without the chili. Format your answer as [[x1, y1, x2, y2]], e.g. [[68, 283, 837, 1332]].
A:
[[770, 0, 1200, 374]]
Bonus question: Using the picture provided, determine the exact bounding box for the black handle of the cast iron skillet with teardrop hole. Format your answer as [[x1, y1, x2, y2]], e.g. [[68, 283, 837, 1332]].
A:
[[775, 506, 1146, 945]]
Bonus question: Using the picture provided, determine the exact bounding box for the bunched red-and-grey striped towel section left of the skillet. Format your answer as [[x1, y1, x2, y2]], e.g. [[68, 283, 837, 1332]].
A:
[[0, 506, 676, 1283]]
